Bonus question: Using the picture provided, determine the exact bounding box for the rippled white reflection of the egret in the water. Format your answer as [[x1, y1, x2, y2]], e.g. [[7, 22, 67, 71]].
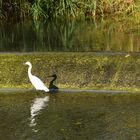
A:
[[29, 96, 49, 132]]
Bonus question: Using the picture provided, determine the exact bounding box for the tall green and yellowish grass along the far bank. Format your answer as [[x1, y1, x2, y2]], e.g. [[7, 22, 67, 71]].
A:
[[0, 0, 140, 21]]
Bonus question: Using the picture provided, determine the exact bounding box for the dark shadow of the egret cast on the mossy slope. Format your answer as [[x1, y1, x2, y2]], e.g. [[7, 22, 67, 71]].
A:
[[48, 74, 59, 93]]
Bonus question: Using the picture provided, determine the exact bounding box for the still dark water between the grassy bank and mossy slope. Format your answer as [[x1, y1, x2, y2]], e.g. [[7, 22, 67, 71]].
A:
[[0, 21, 140, 52]]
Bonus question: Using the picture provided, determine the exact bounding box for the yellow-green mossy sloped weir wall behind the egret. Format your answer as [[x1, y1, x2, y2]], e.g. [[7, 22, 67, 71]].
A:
[[0, 53, 140, 91]]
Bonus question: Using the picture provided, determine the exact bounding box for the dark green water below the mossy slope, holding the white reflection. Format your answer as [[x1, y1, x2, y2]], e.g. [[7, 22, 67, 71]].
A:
[[0, 91, 140, 140]]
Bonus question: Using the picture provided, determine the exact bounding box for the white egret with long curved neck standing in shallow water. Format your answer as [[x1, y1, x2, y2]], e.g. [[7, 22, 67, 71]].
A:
[[25, 62, 49, 92]]
